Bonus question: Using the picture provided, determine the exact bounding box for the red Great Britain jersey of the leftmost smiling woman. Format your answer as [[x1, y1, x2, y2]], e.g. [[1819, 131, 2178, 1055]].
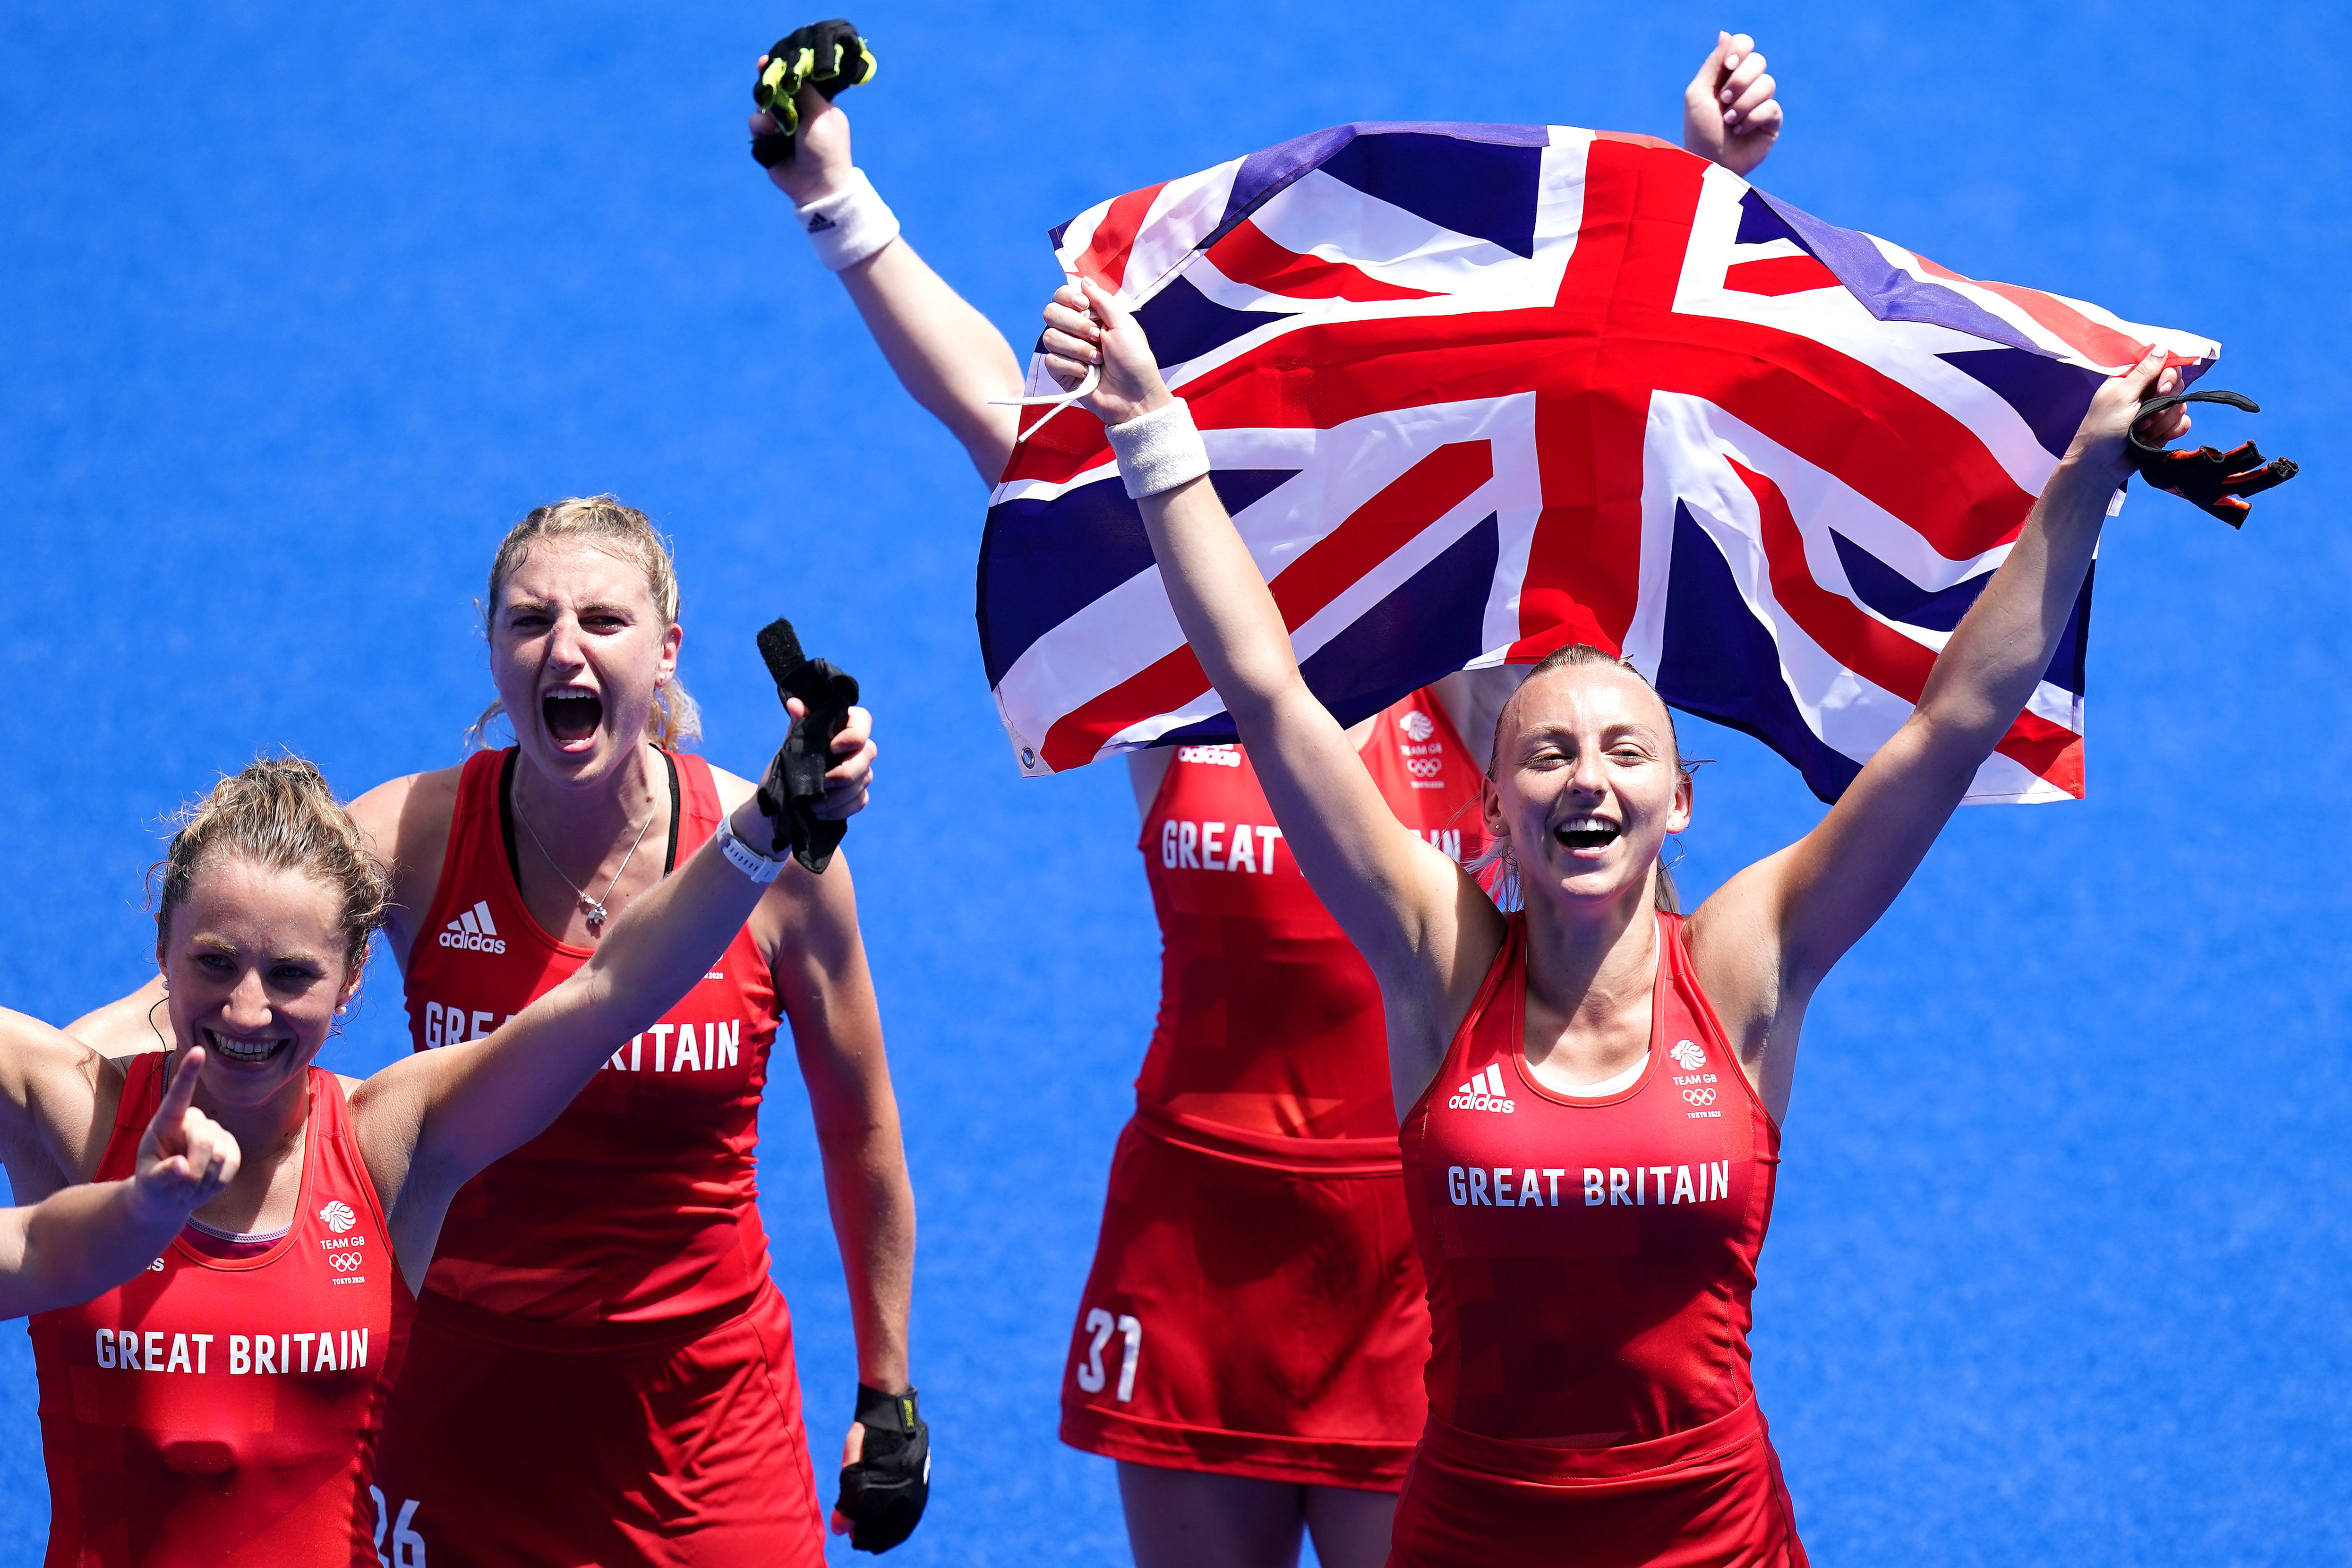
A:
[[31, 1053, 414, 1568]]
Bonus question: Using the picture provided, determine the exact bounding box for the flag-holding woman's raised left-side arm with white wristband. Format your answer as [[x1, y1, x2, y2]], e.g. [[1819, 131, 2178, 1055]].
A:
[[1044, 282, 1503, 1048]]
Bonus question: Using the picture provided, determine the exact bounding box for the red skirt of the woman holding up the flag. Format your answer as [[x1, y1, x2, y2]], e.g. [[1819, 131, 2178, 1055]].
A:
[[1388, 1399, 1806, 1568]]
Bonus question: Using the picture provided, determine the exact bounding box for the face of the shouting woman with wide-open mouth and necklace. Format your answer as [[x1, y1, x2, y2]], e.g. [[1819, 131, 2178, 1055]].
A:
[[489, 539, 684, 780]]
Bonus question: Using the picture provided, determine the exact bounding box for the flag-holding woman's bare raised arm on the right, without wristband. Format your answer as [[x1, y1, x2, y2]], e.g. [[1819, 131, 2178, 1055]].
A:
[[1691, 350, 2189, 1098]]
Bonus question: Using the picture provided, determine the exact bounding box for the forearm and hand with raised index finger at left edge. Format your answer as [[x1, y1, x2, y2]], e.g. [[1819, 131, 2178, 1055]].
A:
[[0, 1046, 238, 1317]]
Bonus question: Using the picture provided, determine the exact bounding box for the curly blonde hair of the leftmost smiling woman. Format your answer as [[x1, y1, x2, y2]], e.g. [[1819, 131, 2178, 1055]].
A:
[[148, 757, 393, 973]]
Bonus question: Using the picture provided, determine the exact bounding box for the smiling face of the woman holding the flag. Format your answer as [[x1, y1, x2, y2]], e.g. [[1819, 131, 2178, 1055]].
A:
[[1484, 663, 1691, 905]]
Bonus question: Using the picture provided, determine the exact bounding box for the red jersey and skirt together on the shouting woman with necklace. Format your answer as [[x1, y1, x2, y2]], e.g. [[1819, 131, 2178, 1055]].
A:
[[379, 752, 823, 1568]]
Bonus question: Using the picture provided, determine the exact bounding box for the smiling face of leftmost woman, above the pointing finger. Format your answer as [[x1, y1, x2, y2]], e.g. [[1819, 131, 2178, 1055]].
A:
[[158, 856, 360, 1107]]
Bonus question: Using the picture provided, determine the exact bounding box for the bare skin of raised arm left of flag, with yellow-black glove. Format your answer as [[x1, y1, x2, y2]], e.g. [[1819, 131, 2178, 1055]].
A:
[[753, 87, 1021, 484]]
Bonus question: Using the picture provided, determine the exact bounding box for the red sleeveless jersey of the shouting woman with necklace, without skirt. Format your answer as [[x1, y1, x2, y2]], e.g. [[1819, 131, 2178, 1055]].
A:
[[407, 747, 776, 1323]]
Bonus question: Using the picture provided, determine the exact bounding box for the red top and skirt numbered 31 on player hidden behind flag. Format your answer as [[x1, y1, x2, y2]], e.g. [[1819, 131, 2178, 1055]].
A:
[[1061, 691, 1484, 1491]]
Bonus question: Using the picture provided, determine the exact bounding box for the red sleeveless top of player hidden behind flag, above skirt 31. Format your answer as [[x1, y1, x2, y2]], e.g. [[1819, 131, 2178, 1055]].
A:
[[1136, 689, 1487, 1157]]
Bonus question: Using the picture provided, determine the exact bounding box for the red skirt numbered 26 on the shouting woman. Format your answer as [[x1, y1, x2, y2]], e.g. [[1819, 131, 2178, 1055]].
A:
[[376, 1281, 826, 1568]]
